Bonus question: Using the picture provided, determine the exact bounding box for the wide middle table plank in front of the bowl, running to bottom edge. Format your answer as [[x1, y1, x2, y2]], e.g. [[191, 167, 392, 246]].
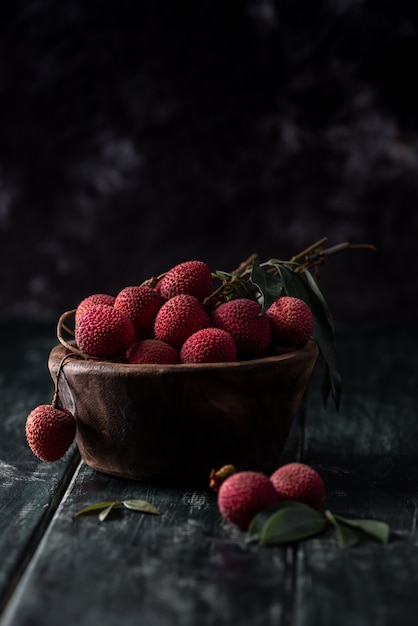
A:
[[0, 465, 291, 626]]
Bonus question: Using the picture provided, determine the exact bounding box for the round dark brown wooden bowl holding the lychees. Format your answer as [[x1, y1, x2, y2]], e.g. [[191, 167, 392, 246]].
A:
[[48, 341, 318, 483]]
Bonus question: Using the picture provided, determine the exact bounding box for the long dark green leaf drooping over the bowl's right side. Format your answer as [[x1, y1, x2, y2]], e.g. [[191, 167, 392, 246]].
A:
[[279, 265, 341, 409]]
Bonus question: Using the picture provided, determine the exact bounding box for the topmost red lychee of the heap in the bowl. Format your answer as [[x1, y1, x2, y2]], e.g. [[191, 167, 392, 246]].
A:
[[158, 261, 212, 302]]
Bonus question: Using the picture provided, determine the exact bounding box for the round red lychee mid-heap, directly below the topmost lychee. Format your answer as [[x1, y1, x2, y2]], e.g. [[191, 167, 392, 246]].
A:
[[154, 294, 211, 348]]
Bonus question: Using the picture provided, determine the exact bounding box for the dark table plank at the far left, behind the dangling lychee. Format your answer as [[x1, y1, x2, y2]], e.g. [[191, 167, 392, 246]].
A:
[[0, 322, 79, 607]]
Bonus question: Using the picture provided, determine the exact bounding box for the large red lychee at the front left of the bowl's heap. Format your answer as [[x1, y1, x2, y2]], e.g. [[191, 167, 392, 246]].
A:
[[75, 304, 135, 359]]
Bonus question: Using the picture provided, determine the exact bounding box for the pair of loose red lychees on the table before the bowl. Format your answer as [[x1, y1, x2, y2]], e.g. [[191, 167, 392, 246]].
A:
[[210, 462, 325, 530]]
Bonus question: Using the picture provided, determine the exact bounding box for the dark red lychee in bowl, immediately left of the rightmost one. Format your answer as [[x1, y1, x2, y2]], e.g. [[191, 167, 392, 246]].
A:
[[212, 298, 270, 358]]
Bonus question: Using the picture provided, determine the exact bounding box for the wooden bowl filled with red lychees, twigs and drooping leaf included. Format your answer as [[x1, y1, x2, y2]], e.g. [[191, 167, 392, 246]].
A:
[[26, 241, 350, 481]]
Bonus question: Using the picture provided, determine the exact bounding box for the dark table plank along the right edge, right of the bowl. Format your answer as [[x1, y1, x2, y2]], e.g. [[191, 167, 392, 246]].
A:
[[293, 330, 418, 626]]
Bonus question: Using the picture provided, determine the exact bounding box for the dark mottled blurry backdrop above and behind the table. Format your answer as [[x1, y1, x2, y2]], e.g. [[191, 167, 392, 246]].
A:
[[0, 0, 418, 324]]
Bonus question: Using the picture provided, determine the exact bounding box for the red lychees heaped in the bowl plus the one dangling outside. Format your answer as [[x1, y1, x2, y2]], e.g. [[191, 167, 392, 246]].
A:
[[26, 260, 314, 461]]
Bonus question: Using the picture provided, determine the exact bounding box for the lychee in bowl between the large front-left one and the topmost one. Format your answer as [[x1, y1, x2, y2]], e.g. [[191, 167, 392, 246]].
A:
[[114, 285, 165, 337]]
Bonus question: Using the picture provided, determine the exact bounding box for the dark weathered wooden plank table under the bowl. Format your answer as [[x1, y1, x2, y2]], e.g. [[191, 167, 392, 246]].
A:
[[0, 321, 418, 626]]
